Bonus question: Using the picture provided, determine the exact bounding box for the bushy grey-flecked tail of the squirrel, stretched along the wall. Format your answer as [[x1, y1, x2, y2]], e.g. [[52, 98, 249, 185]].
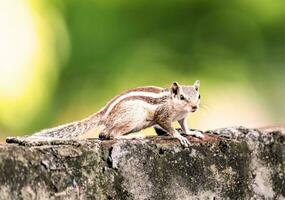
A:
[[30, 113, 101, 139]]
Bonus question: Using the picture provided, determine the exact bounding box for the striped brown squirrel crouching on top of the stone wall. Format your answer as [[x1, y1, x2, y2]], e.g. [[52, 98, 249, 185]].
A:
[[30, 80, 204, 147]]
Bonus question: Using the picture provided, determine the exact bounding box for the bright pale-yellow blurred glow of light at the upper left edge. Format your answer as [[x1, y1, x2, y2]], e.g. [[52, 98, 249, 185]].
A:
[[0, 0, 68, 136]]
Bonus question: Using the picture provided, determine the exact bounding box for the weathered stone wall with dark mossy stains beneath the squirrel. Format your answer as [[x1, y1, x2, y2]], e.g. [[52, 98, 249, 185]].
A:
[[0, 127, 285, 200]]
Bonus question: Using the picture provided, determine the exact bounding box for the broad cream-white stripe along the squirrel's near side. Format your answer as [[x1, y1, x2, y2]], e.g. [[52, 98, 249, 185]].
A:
[[104, 91, 169, 117]]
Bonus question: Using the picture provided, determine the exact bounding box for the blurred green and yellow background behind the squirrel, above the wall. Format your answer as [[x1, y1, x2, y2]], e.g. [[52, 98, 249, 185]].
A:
[[0, 0, 285, 140]]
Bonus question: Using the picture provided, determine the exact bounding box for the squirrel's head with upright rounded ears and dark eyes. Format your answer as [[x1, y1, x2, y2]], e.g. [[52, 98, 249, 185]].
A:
[[170, 80, 201, 112]]
